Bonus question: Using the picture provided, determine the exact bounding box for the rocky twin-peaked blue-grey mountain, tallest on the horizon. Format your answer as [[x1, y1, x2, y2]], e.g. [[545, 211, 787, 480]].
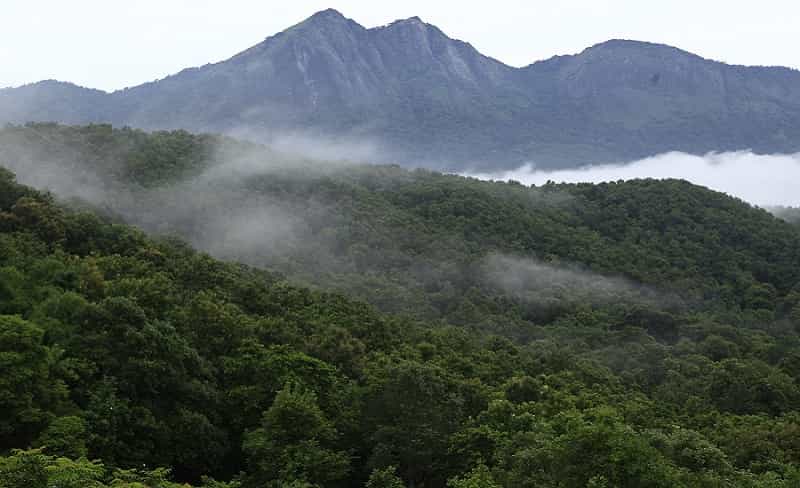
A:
[[112, 11, 524, 166]]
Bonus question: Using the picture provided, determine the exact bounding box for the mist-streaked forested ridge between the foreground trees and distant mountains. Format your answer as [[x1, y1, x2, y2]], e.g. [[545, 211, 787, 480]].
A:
[[0, 125, 800, 337]]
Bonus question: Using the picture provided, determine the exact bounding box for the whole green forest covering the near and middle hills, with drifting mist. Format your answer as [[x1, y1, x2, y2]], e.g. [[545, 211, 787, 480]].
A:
[[0, 125, 800, 488]]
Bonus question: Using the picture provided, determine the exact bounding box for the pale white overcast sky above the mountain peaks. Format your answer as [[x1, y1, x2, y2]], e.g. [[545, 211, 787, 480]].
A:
[[0, 0, 800, 90]]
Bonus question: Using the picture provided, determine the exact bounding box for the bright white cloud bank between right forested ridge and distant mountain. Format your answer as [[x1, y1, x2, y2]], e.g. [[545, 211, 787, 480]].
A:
[[466, 151, 800, 207]]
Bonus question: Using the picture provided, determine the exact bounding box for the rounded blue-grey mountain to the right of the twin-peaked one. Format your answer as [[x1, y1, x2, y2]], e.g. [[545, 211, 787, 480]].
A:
[[525, 40, 800, 160]]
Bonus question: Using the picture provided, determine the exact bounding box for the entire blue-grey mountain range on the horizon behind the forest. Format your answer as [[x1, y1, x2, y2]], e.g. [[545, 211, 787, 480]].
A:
[[0, 10, 800, 170]]
